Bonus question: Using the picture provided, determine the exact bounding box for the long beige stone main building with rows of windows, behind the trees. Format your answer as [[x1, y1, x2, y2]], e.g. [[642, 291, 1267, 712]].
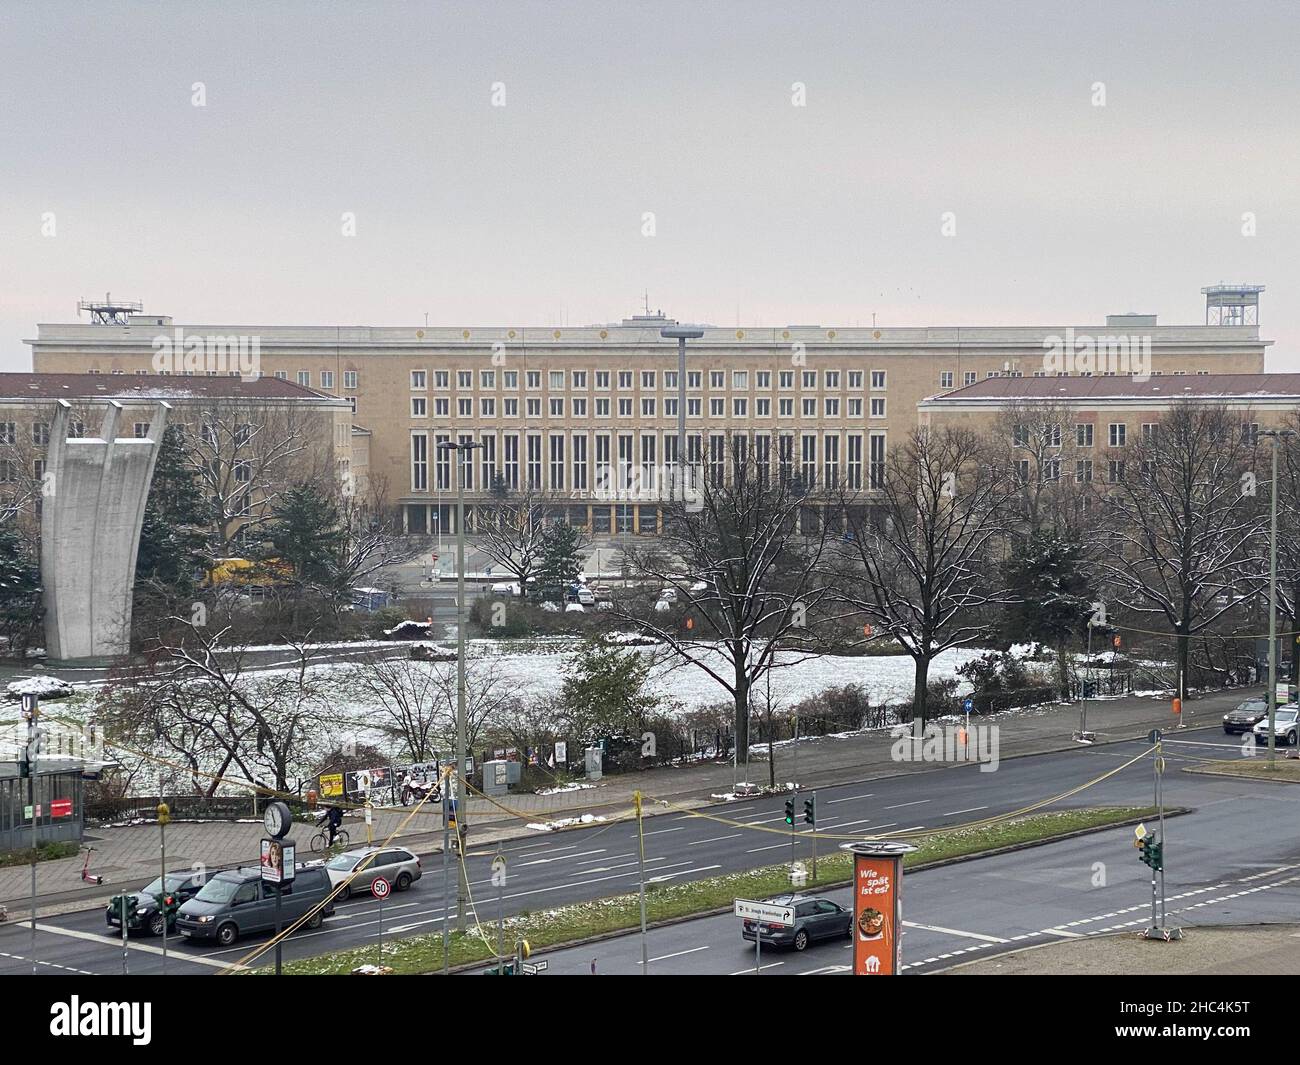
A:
[[30, 291, 1269, 534]]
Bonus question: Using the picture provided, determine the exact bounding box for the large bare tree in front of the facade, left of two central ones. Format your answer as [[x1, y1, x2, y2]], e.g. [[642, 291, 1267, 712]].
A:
[[620, 441, 839, 761]]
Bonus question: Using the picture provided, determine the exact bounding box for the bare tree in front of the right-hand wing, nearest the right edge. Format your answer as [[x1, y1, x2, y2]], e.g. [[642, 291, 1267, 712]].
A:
[[1097, 402, 1268, 684]]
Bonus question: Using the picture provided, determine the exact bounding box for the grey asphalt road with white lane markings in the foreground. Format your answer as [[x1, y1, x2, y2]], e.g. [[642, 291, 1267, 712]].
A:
[[0, 731, 1284, 974]]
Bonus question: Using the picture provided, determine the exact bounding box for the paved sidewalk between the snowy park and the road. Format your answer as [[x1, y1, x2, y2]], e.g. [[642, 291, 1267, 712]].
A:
[[0, 688, 1248, 919]]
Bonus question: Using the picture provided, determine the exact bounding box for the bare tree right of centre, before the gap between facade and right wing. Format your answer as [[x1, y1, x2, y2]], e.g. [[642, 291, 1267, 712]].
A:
[[836, 428, 1017, 723]]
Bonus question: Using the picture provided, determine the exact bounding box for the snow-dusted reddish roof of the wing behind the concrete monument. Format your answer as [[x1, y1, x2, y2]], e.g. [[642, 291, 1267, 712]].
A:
[[0, 373, 347, 403]]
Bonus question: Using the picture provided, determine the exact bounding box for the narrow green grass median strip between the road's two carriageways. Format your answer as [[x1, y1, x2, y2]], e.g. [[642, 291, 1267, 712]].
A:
[[271, 806, 1151, 975]]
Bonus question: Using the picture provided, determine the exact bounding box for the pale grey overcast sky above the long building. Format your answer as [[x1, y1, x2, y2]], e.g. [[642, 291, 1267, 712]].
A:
[[0, 0, 1300, 369]]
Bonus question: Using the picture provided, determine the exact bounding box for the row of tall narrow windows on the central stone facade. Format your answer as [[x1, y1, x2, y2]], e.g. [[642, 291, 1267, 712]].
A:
[[411, 432, 885, 493]]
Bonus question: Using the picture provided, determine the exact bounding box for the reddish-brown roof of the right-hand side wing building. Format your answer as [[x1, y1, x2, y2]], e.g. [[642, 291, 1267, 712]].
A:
[[922, 373, 1300, 408]]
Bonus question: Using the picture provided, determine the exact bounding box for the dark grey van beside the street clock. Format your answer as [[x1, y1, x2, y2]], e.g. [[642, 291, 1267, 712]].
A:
[[176, 865, 334, 947]]
